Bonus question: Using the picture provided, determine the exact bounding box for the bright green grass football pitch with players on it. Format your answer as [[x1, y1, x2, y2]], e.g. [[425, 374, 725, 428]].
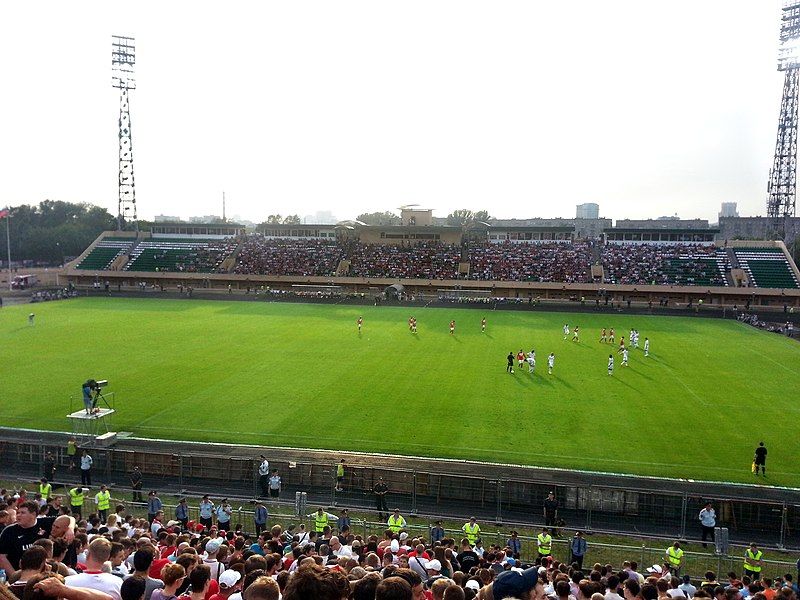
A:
[[0, 298, 800, 486]]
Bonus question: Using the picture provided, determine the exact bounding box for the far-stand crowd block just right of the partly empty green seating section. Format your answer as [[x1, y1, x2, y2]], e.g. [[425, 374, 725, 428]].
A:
[[234, 235, 343, 276]]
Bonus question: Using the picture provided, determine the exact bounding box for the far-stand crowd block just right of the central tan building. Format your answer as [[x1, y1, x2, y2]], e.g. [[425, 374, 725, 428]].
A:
[[469, 242, 592, 283]]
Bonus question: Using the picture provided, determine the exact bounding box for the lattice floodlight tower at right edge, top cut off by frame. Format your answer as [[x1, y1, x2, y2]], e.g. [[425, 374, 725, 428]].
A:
[[767, 0, 800, 239]]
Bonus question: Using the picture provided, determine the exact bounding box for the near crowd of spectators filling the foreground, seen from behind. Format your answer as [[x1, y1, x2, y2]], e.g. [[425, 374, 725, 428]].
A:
[[0, 486, 798, 600]]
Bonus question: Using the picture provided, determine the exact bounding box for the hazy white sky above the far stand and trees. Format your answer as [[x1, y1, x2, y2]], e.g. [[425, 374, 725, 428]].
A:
[[0, 0, 783, 222]]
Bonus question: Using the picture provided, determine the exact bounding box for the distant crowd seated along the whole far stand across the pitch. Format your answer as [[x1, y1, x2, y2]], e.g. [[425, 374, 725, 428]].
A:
[[176, 235, 740, 285]]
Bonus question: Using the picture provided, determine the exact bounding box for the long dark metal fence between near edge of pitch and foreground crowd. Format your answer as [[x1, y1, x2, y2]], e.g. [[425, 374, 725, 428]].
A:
[[0, 441, 800, 548]]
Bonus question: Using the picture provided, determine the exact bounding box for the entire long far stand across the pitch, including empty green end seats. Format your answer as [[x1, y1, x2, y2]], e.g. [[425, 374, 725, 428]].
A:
[[69, 234, 800, 289]]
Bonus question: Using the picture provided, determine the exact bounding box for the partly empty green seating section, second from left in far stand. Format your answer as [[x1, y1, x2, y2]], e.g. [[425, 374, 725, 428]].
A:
[[124, 239, 237, 273]]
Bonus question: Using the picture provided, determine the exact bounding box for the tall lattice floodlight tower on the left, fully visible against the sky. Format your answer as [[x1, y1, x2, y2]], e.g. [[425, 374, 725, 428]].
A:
[[111, 35, 139, 231]]
